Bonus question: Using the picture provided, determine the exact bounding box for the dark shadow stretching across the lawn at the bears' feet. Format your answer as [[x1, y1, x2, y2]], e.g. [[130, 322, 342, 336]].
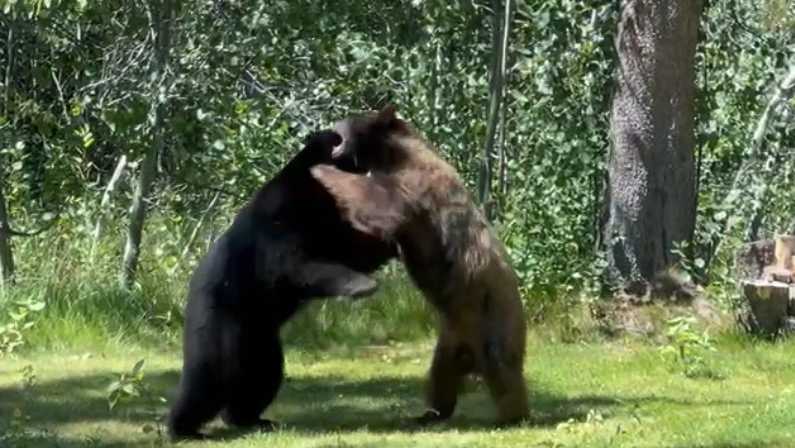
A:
[[0, 370, 746, 440]]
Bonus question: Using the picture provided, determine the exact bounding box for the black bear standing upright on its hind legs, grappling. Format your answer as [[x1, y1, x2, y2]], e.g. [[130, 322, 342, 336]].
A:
[[168, 131, 396, 438]]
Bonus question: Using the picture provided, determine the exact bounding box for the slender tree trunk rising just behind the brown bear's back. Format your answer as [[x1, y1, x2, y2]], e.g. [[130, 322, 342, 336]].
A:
[[479, 0, 513, 217]]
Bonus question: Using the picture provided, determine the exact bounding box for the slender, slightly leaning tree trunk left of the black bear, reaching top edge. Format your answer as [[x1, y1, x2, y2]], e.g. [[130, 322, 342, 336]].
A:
[[121, 0, 178, 288]]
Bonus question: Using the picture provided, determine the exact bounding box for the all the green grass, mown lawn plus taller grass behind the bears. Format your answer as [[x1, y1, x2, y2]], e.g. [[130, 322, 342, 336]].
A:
[[0, 245, 795, 448]]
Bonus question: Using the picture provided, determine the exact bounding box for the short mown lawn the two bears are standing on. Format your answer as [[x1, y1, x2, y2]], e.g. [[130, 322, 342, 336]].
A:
[[0, 335, 795, 448]]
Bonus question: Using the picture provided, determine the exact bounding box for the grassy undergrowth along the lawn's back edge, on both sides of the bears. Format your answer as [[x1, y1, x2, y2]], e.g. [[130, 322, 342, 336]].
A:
[[0, 216, 744, 355]]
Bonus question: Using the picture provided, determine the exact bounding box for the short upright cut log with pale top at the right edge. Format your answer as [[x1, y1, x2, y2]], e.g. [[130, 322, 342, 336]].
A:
[[743, 280, 790, 335]]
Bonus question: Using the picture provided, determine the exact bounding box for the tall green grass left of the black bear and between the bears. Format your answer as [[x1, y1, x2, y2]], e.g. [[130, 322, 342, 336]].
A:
[[0, 255, 434, 351]]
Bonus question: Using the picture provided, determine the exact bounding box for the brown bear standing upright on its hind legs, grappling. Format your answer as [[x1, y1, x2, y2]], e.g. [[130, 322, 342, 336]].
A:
[[311, 106, 528, 424]]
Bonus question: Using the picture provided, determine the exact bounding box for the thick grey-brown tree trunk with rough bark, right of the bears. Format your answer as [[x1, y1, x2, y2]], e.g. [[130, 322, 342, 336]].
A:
[[603, 0, 701, 294]]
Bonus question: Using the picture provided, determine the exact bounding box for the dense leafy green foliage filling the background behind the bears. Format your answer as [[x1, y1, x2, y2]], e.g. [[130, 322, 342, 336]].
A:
[[0, 0, 795, 344]]
